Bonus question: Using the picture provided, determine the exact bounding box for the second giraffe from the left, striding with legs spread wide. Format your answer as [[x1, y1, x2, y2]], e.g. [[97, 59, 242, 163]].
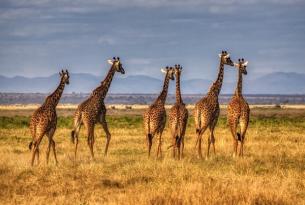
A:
[[71, 57, 125, 160]]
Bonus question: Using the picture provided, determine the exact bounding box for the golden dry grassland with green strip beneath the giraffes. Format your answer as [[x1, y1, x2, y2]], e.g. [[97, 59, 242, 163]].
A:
[[0, 108, 305, 204]]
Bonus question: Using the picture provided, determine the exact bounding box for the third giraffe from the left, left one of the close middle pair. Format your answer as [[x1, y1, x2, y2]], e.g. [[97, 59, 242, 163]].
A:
[[143, 67, 175, 158]]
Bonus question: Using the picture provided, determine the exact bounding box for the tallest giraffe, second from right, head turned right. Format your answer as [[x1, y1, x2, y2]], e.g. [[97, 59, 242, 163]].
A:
[[194, 51, 234, 159]]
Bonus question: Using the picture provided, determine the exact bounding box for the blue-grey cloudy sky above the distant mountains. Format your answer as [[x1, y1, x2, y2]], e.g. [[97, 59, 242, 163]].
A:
[[0, 0, 305, 79]]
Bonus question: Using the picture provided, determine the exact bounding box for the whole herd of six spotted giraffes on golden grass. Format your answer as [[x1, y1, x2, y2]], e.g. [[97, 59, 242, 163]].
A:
[[29, 51, 250, 166]]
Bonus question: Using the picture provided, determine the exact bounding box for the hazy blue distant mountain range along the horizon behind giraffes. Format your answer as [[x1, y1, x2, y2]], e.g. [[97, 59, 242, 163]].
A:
[[0, 72, 305, 94]]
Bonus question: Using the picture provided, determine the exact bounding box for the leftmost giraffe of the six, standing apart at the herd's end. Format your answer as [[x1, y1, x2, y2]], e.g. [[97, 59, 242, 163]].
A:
[[29, 70, 70, 166]]
